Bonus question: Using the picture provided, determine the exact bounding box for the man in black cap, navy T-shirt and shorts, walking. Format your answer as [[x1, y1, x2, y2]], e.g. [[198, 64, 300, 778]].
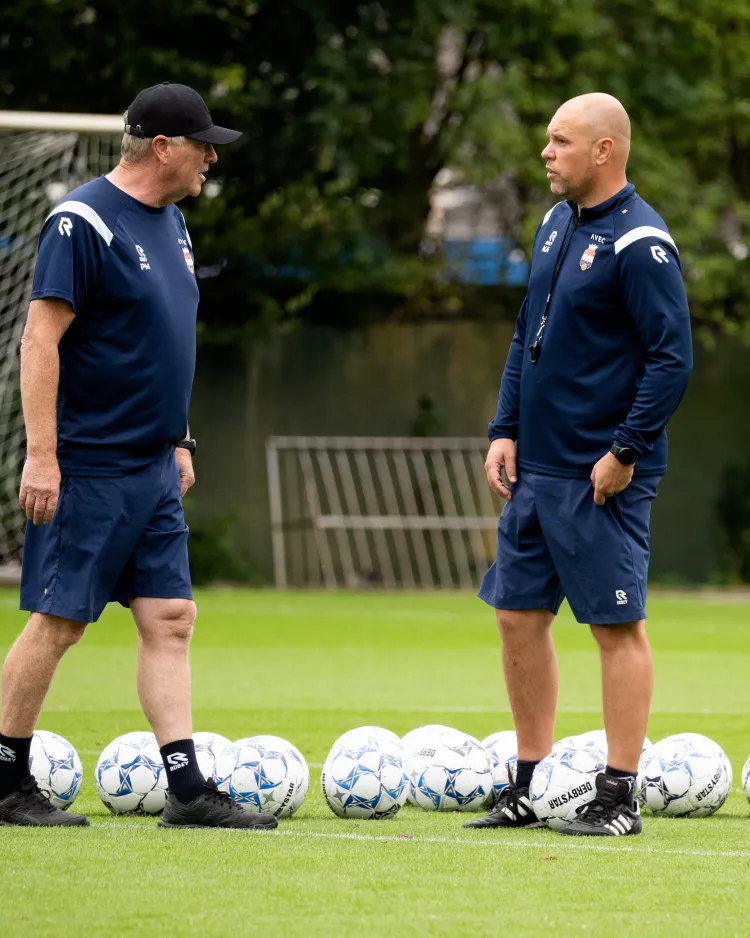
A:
[[0, 82, 277, 829]]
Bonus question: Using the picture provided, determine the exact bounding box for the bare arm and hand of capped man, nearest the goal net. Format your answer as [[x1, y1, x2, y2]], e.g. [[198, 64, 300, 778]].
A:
[[18, 299, 75, 524]]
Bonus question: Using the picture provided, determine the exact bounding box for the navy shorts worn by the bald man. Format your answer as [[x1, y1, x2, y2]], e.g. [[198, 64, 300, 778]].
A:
[[479, 472, 660, 625]]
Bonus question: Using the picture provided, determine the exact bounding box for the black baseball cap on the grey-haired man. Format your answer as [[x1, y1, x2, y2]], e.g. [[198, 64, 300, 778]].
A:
[[125, 81, 242, 143]]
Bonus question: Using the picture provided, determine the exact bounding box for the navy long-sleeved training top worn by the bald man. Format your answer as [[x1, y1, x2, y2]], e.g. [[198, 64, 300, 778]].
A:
[[489, 185, 693, 478]]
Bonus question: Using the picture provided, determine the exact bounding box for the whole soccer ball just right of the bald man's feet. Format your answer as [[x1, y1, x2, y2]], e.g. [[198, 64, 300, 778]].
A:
[[638, 733, 732, 817]]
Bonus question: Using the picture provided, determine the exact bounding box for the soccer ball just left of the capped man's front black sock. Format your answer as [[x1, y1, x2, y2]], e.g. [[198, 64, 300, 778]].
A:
[[94, 732, 167, 814]]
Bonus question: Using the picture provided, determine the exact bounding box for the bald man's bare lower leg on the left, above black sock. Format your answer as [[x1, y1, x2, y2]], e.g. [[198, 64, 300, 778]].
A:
[[497, 609, 558, 762]]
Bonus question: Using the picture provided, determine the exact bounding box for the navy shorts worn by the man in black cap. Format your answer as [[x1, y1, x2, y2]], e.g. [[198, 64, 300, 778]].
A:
[[21, 447, 192, 622]]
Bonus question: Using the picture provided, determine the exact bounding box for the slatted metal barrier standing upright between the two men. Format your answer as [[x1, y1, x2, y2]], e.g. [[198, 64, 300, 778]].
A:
[[266, 436, 502, 589]]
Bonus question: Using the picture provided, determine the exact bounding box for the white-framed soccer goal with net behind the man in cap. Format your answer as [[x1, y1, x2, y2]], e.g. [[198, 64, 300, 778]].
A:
[[0, 111, 123, 565]]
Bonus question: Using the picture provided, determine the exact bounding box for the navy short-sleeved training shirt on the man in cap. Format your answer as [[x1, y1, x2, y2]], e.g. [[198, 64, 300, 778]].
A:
[[31, 176, 198, 476]]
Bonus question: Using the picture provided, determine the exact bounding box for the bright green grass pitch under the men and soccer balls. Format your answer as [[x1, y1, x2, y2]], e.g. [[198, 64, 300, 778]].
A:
[[0, 591, 750, 938]]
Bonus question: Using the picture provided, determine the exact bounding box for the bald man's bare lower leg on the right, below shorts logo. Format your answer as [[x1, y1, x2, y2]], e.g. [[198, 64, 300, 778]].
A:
[[591, 619, 654, 775]]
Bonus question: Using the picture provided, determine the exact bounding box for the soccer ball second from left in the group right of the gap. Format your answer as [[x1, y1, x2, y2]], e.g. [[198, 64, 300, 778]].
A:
[[409, 729, 492, 811]]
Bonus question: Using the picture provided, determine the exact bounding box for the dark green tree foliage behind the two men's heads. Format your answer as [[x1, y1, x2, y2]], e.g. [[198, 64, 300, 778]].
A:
[[0, 0, 750, 340]]
